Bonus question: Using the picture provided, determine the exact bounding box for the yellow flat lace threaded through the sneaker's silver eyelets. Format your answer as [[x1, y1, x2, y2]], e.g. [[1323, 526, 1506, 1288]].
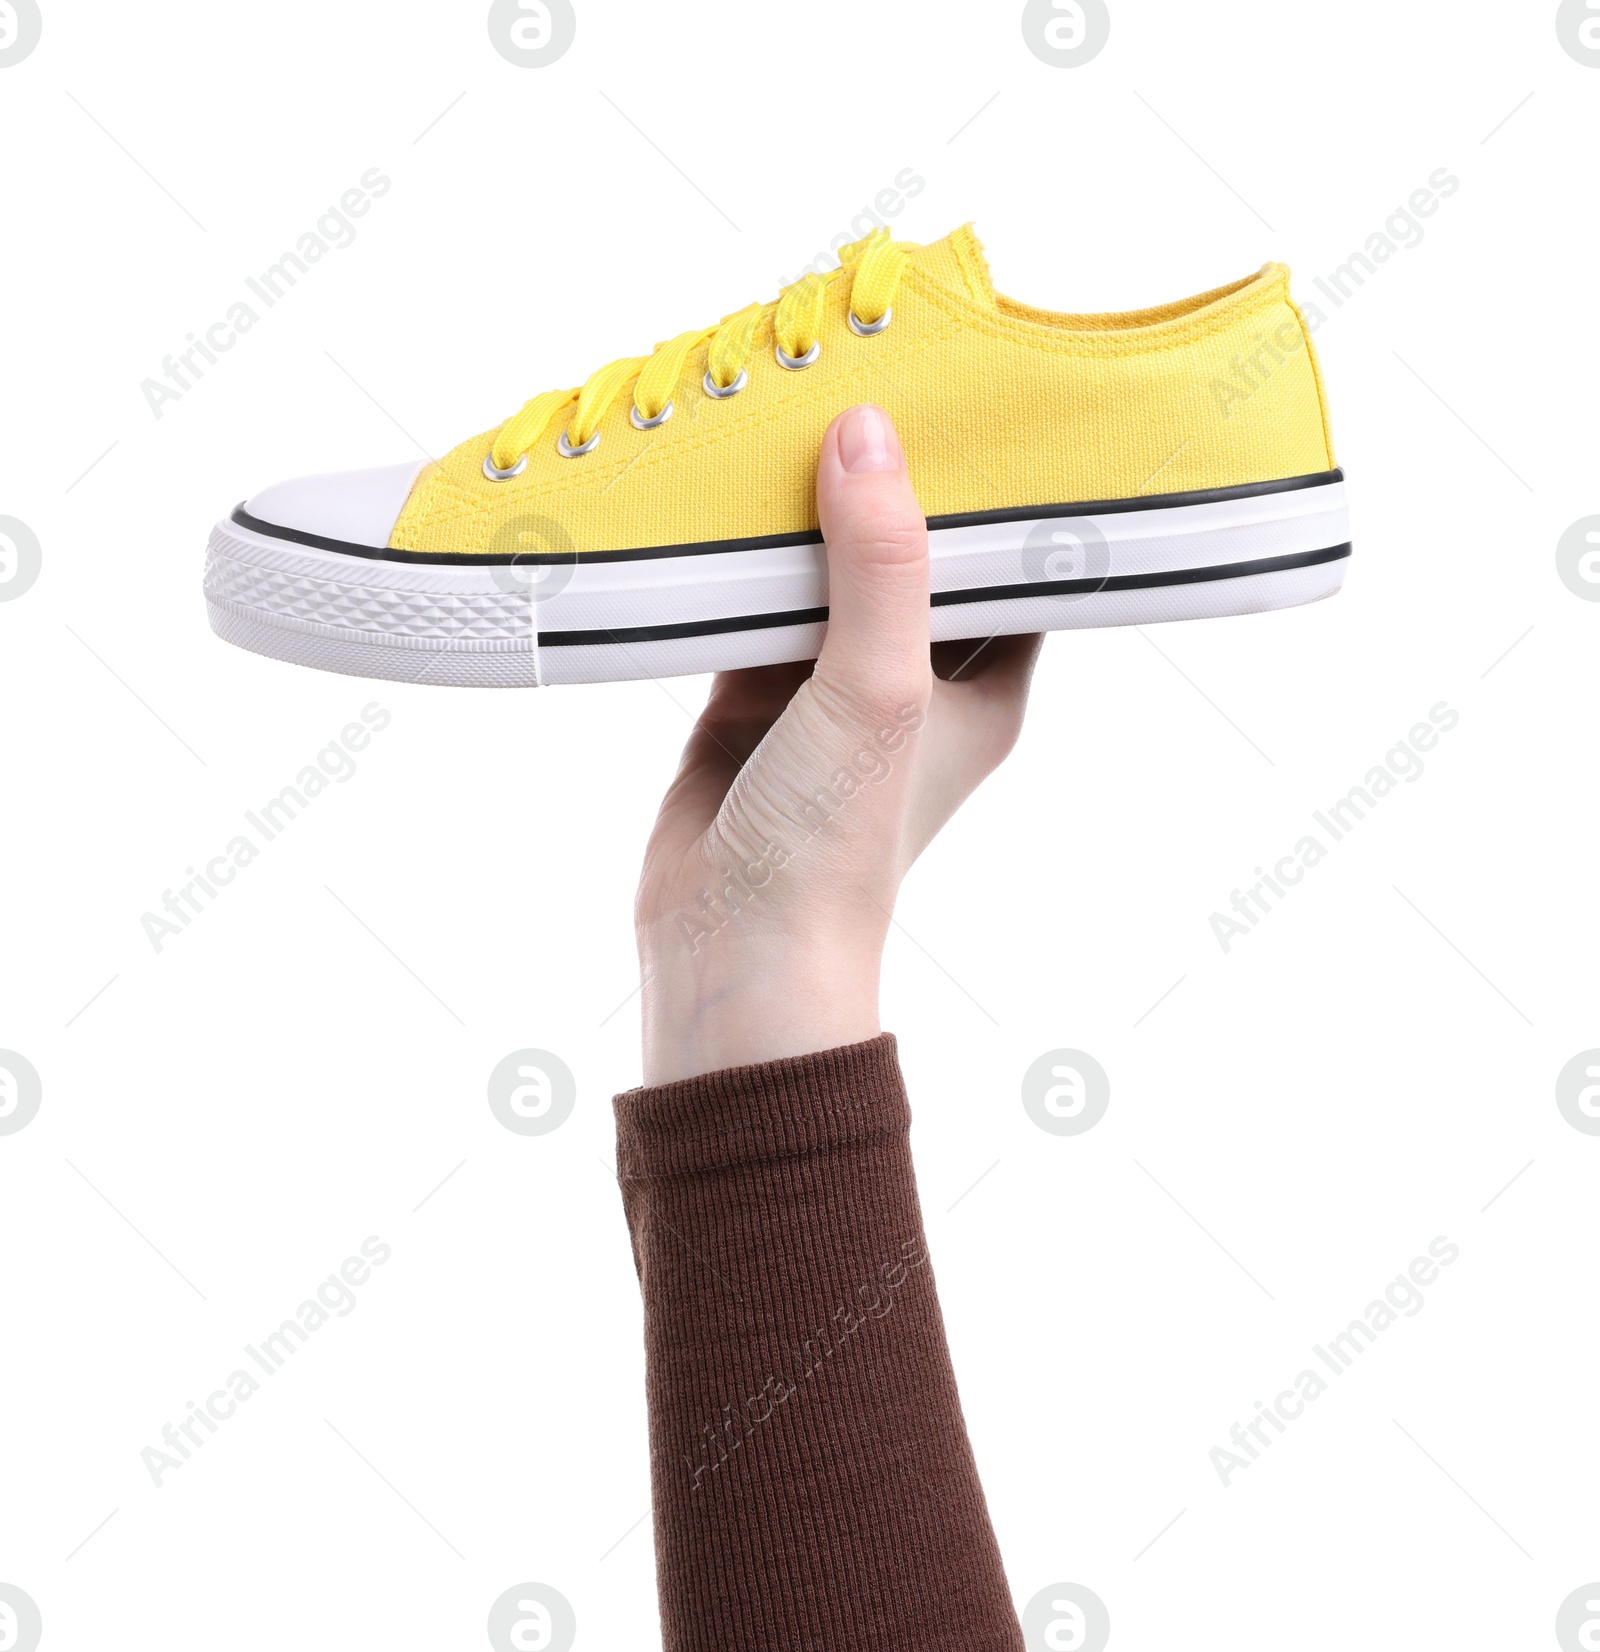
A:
[[484, 230, 910, 479]]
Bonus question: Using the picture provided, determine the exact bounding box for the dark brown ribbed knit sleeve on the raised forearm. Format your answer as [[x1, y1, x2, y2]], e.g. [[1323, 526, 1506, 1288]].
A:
[[616, 1034, 1022, 1652]]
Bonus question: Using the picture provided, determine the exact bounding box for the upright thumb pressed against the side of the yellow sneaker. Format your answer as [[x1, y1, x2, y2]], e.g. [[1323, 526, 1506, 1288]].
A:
[[817, 405, 931, 702]]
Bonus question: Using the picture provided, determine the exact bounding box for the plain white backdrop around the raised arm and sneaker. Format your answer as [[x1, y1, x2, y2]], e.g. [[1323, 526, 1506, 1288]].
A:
[[0, 0, 1600, 1652]]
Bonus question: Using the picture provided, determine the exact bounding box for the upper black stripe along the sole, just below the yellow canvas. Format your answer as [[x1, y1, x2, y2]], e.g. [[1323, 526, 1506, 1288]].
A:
[[231, 471, 1344, 568]]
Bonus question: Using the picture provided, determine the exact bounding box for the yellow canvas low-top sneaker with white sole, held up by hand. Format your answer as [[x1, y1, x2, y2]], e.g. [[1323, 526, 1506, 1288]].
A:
[[205, 228, 1351, 687]]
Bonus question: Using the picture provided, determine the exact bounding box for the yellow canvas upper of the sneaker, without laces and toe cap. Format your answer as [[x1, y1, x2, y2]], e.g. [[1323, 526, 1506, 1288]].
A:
[[368, 226, 1336, 555]]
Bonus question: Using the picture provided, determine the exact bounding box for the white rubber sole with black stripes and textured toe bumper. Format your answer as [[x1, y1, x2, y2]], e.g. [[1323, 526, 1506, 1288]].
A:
[[205, 471, 1351, 687]]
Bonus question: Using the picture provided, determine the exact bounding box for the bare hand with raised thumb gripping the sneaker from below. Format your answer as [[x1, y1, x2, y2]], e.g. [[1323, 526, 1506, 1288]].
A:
[[636, 406, 1039, 1084]]
